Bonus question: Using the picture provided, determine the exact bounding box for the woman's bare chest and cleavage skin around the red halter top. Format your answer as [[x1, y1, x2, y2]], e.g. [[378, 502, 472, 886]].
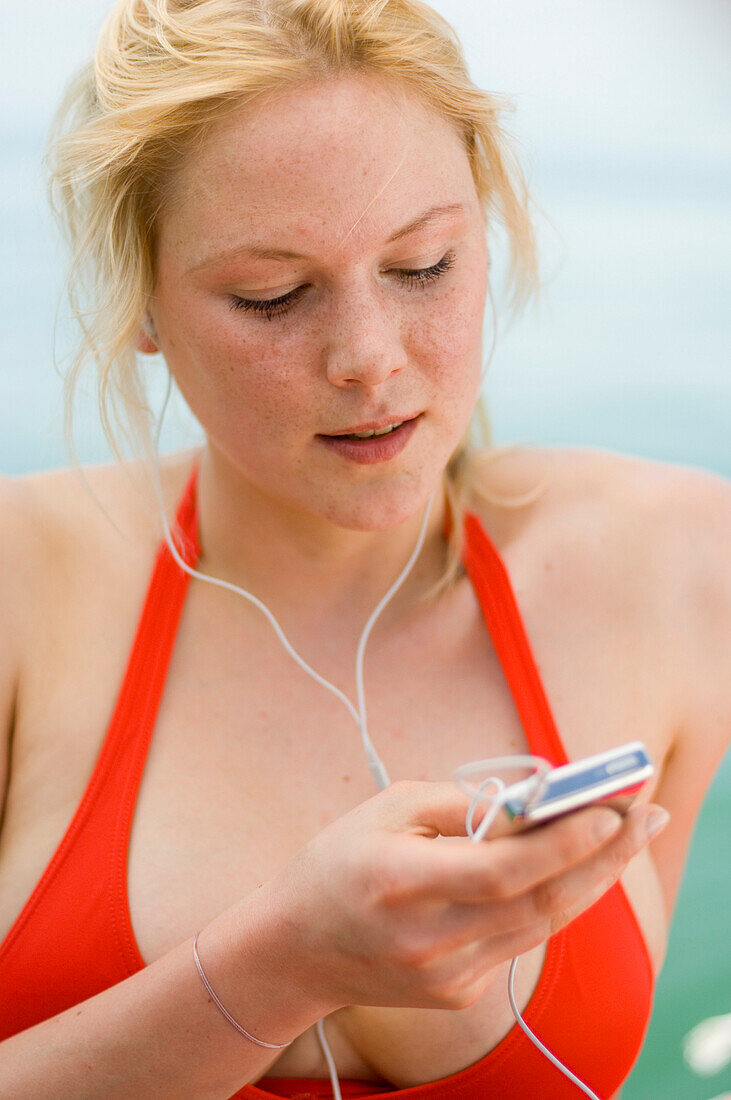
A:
[[3, 550, 665, 1078]]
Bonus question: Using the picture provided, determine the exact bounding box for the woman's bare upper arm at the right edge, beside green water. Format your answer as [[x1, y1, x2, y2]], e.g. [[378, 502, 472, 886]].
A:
[[633, 468, 731, 917]]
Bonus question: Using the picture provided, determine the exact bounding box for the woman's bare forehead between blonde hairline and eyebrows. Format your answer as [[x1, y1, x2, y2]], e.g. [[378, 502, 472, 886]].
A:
[[163, 76, 476, 257]]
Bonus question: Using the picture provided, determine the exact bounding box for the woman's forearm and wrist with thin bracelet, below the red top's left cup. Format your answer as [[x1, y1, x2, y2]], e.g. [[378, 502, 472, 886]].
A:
[[0, 889, 332, 1100]]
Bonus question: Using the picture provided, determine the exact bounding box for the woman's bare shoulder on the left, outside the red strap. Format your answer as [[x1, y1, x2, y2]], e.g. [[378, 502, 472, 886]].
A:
[[0, 452, 200, 825]]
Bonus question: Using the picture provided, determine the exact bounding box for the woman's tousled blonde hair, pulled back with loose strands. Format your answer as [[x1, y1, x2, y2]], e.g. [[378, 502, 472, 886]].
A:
[[47, 0, 545, 576]]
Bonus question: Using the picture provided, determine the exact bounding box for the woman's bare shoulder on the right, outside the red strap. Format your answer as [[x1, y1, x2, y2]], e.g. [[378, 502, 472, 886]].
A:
[[475, 447, 731, 598]]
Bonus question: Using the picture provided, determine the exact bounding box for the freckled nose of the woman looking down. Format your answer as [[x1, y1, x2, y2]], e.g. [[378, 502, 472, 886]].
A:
[[325, 295, 407, 388]]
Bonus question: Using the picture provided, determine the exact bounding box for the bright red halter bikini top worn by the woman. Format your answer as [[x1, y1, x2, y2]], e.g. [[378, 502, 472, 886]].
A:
[[0, 473, 653, 1100]]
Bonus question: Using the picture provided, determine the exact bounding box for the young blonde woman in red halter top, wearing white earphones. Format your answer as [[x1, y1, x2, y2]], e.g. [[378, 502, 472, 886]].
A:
[[0, 0, 731, 1100]]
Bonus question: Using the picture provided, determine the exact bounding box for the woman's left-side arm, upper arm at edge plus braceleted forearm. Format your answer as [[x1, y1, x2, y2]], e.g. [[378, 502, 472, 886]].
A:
[[0, 477, 329, 1100]]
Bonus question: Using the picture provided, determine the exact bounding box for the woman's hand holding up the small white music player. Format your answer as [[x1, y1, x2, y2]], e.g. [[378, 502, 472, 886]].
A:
[[267, 781, 658, 1011]]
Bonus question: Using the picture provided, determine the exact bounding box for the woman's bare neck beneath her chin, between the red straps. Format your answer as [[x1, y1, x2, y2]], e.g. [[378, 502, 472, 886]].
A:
[[191, 448, 446, 634]]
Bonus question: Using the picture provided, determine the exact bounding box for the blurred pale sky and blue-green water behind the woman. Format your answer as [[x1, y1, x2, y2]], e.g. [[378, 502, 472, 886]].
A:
[[0, 0, 731, 1100]]
